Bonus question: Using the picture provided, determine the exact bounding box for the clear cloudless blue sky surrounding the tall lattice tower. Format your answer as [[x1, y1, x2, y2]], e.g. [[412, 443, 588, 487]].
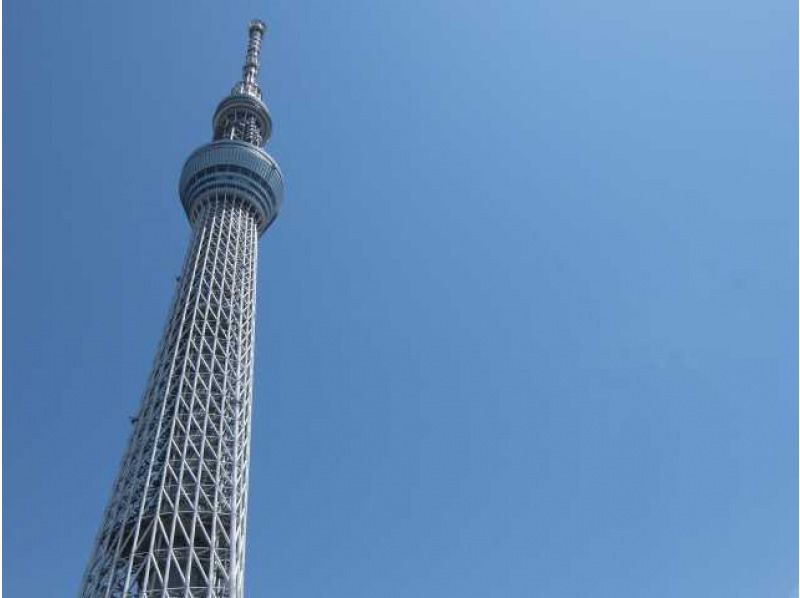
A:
[[3, 0, 798, 598]]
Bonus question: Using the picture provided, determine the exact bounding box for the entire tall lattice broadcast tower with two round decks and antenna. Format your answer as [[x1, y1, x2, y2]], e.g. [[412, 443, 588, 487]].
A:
[[80, 21, 283, 598]]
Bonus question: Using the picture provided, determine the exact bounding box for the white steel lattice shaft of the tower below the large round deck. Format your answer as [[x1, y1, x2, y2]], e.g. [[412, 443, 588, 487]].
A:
[[84, 195, 258, 597]]
